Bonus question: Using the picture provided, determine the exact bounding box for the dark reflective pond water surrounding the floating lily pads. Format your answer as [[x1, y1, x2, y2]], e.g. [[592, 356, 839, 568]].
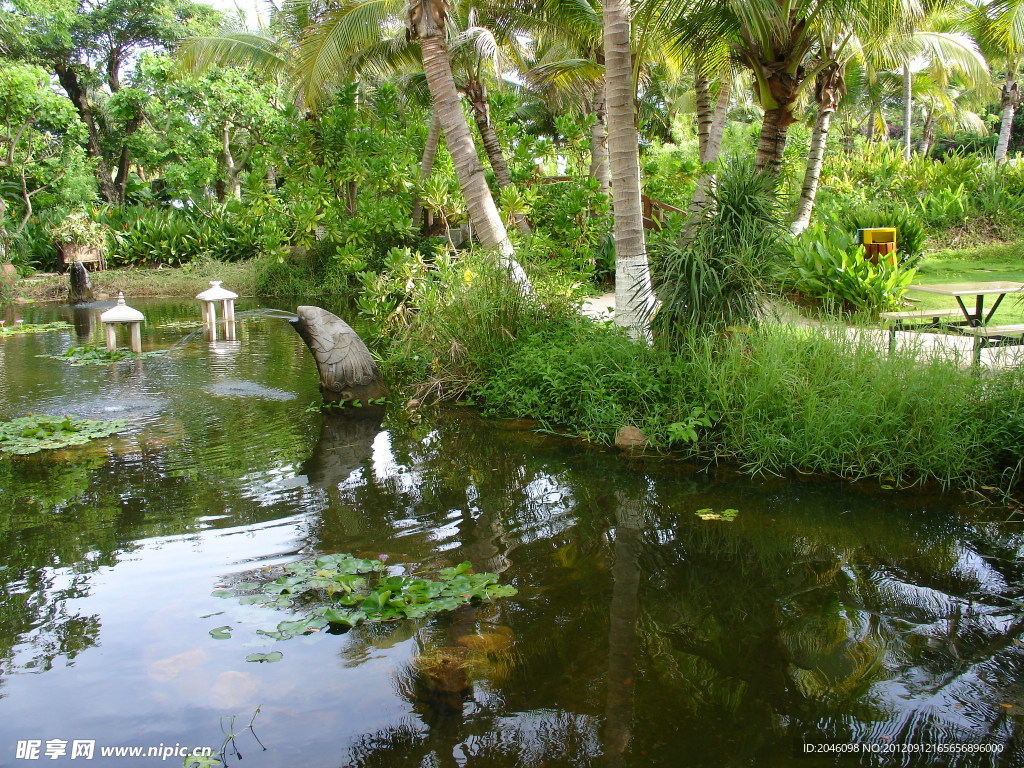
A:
[[0, 301, 1024, 768]]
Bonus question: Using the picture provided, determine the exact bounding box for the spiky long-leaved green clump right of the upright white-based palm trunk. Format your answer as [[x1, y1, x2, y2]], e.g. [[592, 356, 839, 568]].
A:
[[651, 161, 784, 343]]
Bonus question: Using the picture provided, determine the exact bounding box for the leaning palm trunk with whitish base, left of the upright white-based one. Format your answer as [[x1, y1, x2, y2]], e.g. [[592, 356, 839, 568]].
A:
[[420, 29, 532, 292]]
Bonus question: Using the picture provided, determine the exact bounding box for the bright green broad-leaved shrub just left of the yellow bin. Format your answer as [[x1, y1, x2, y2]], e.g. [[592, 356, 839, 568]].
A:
[[792, 223, 918, 313]]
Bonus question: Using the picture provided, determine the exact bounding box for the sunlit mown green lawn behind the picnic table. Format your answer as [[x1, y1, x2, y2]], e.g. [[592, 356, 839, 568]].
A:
[[908, 244, 1024, 325]]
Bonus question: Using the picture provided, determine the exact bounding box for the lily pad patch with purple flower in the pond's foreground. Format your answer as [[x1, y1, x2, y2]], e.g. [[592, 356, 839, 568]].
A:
[[210, 554, 516, 662]]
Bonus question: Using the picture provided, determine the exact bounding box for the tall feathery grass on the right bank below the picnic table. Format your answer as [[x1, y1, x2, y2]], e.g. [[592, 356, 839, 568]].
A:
[[687, 327, 1024, 484]]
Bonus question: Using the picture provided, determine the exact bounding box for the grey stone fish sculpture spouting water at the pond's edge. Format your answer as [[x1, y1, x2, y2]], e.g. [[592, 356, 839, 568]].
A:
[[291, 306, 387, 404]]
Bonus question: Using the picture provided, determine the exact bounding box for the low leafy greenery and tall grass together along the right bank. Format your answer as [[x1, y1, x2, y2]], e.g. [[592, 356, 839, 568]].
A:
[[454, 324, 1024, 489]]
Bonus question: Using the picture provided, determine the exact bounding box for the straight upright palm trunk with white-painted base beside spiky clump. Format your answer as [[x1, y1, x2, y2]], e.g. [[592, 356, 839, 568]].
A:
[[602, 0, 654, 338]]
